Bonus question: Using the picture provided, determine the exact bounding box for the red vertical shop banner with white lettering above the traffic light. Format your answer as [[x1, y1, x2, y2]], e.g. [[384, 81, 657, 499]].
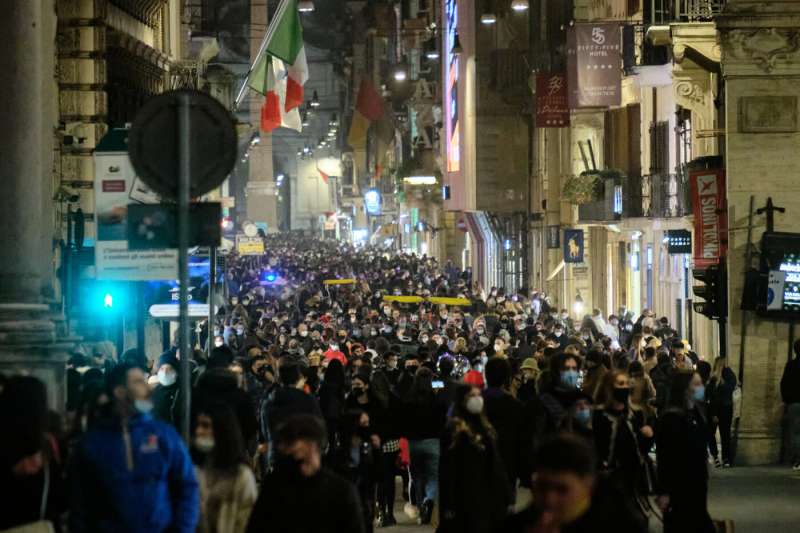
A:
[[689, 169, 728, 267]]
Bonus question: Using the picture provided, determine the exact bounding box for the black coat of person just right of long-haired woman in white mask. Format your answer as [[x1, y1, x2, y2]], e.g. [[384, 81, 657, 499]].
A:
[[483, 387, 525, 485]]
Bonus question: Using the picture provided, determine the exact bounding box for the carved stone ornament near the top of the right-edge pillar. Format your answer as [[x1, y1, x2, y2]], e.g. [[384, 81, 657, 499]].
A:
[[723, 28, 800, 74]]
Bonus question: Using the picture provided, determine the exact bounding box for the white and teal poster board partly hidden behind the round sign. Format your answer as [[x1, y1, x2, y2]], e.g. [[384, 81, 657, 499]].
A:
[[94, 129, 178, 281]]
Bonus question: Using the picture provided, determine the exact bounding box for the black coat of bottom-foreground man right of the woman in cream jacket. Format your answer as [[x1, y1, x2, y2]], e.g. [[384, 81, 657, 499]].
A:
[[247, 466, 365, 533]]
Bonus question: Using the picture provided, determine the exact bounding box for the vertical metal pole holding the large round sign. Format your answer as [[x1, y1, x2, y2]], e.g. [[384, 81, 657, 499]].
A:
[[178, 93, 192, 442]]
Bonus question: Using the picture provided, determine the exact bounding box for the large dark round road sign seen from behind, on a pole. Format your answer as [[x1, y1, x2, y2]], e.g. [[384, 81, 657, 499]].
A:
[[128, 90, 237, 199]]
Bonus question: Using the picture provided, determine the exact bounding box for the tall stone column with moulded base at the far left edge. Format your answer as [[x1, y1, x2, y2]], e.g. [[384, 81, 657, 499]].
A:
[[0, 0, 68, 408]]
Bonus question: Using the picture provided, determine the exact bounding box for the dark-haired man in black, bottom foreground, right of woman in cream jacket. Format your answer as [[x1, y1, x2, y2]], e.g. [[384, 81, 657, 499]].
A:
[[247, 415, 366, 533]]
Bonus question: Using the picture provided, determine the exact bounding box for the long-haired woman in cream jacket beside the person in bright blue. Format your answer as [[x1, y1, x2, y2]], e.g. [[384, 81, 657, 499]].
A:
[[192, 403, 258, 533]]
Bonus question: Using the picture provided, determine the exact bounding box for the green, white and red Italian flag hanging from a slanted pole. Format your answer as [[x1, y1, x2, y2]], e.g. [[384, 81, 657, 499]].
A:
[[247, 0, 308, 132]]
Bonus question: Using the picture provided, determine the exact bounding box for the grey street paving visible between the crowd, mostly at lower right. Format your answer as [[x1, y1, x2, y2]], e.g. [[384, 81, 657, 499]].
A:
[[380, 466, 800, 533]]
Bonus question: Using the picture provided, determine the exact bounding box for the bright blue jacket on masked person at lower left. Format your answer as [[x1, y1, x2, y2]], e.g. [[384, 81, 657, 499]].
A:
[[69, 414, 199, 533]]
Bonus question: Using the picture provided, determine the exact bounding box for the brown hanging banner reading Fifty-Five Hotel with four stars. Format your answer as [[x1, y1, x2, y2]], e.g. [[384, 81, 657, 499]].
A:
[[567, 23, 622, 109]]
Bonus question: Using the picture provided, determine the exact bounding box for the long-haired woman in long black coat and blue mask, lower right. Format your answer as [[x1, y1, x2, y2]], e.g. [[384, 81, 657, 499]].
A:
[[656, 370, 715, 533]]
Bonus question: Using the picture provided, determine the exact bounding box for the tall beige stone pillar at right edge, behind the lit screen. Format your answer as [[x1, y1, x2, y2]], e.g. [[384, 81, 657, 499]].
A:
[[718, 0, 800, 464]]
